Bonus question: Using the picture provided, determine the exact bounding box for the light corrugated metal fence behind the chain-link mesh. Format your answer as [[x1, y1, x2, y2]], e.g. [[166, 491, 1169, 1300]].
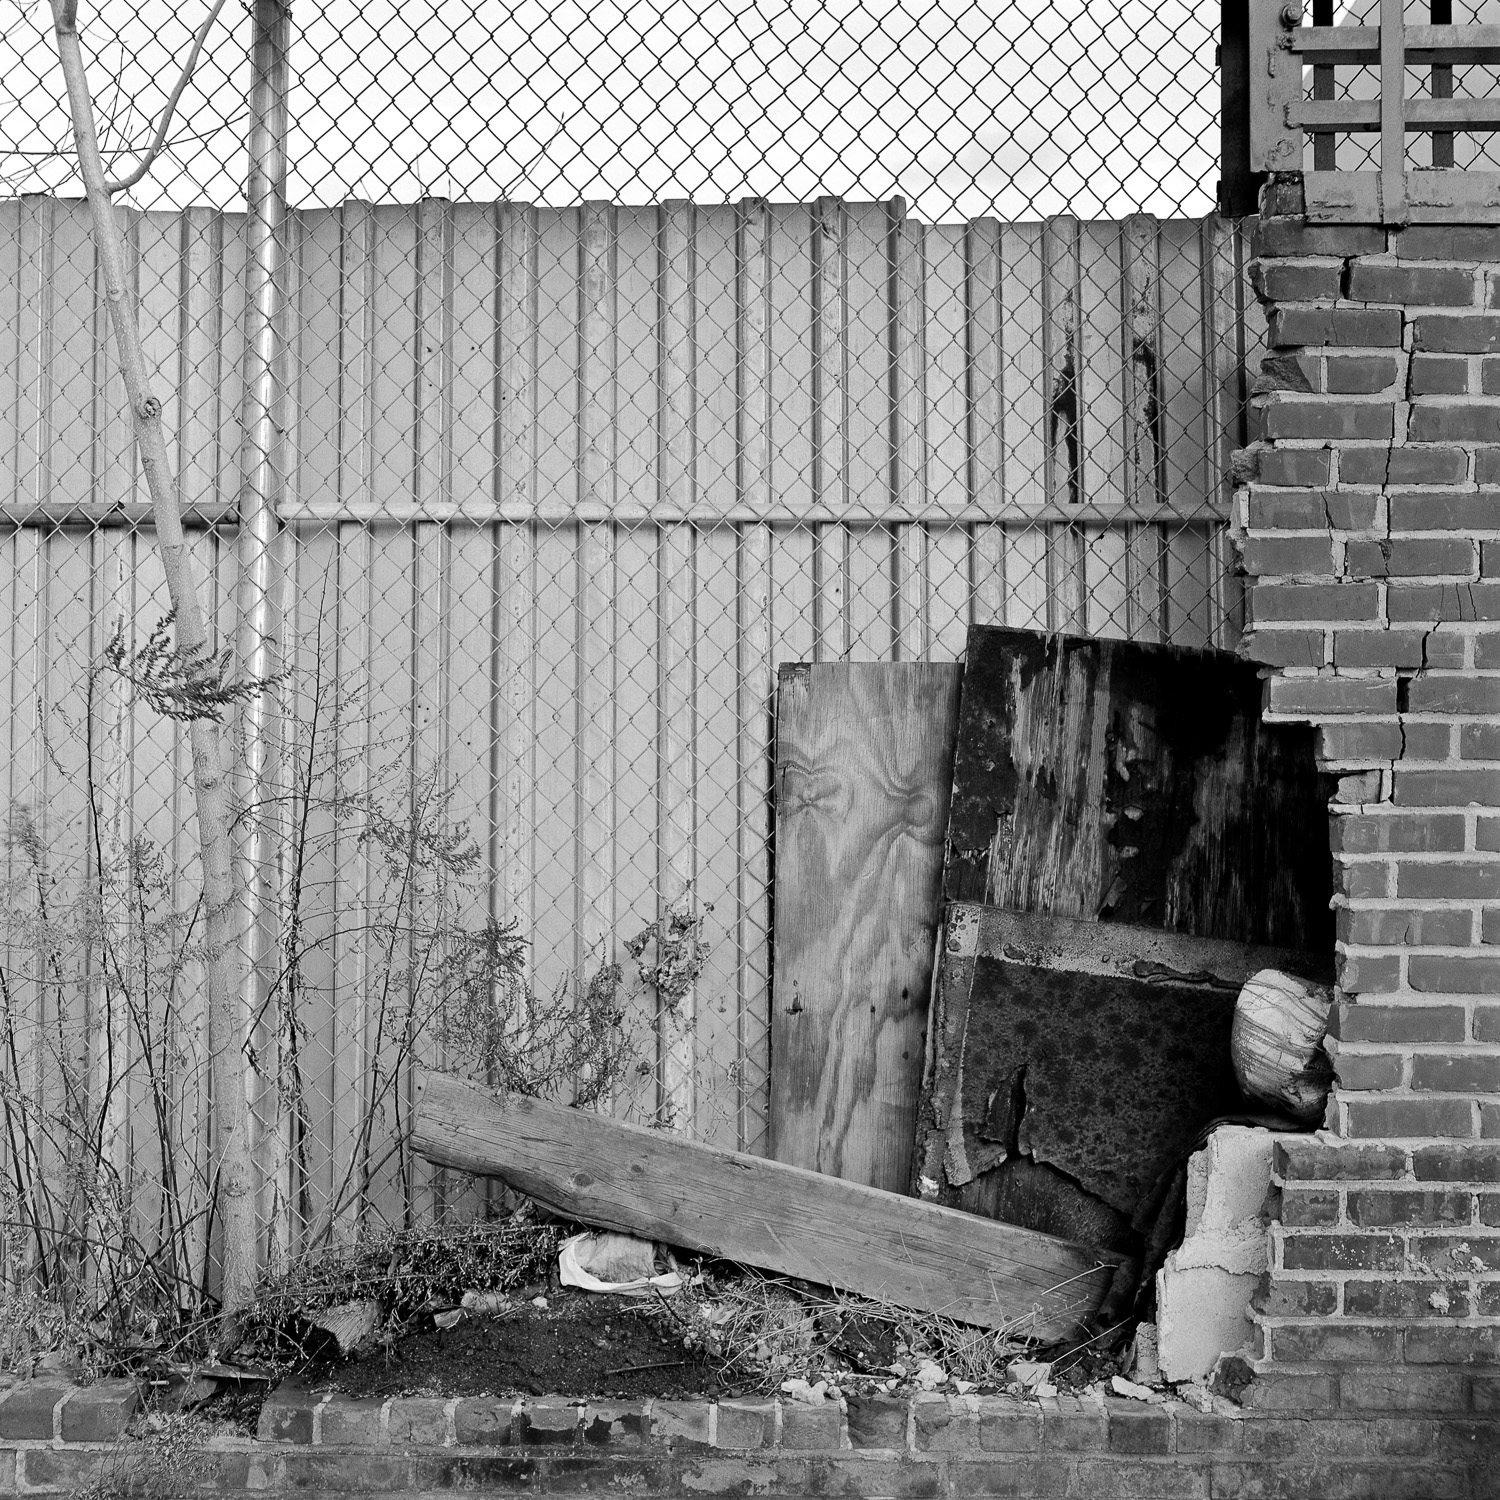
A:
[[0, 198, 1256, 1248]]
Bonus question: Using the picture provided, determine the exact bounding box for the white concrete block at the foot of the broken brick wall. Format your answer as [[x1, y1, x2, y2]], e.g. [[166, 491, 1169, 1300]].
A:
[[1157, 1125, 1280, 1382]]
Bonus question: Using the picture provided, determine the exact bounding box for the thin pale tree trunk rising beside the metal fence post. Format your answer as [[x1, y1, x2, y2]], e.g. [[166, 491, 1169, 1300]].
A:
[[53, 0, 255, 1343]]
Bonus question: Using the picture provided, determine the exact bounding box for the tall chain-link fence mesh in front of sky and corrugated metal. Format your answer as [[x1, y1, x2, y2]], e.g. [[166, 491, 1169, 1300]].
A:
[[0, 0, 1242, 1280]]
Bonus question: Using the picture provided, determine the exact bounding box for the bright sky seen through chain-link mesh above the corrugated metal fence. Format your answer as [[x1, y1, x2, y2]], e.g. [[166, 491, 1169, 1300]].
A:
[[0, 0, 1220, 222]]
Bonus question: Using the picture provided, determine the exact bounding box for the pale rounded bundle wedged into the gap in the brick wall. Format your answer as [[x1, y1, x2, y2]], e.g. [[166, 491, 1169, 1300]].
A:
[[1229, 969, 1334, 1124]]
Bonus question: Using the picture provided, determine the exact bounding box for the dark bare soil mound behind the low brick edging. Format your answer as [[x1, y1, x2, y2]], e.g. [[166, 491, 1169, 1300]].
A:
[[302, 1292, 728, 1398]]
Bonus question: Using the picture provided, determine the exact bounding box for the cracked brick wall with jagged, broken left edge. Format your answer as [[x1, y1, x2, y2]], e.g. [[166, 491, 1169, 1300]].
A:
[[1236, 179, 1500, 1412]]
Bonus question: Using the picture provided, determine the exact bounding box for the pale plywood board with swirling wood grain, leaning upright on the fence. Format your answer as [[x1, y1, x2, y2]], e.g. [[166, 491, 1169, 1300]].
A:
[[771, 662, 962, 1193]]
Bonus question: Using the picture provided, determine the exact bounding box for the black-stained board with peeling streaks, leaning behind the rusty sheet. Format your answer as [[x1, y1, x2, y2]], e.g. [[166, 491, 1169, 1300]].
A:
[[945, 626, 1334, 953]]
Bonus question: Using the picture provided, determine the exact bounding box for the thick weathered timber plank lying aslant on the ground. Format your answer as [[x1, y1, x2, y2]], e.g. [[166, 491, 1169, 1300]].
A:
[[413, 1073, 1122, 1341]]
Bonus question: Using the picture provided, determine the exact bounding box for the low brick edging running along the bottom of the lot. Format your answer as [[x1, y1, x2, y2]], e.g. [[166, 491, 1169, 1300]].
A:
[[0, 1367, 1500, 1500]]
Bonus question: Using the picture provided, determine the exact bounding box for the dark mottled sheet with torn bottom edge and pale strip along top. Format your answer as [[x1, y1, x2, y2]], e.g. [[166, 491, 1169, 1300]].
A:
[[917, 903, 1326, 1223]]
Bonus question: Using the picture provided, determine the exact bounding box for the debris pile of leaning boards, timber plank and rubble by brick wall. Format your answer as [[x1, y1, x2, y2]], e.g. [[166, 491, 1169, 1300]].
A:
[[413, 627, 1332, 1410]]
